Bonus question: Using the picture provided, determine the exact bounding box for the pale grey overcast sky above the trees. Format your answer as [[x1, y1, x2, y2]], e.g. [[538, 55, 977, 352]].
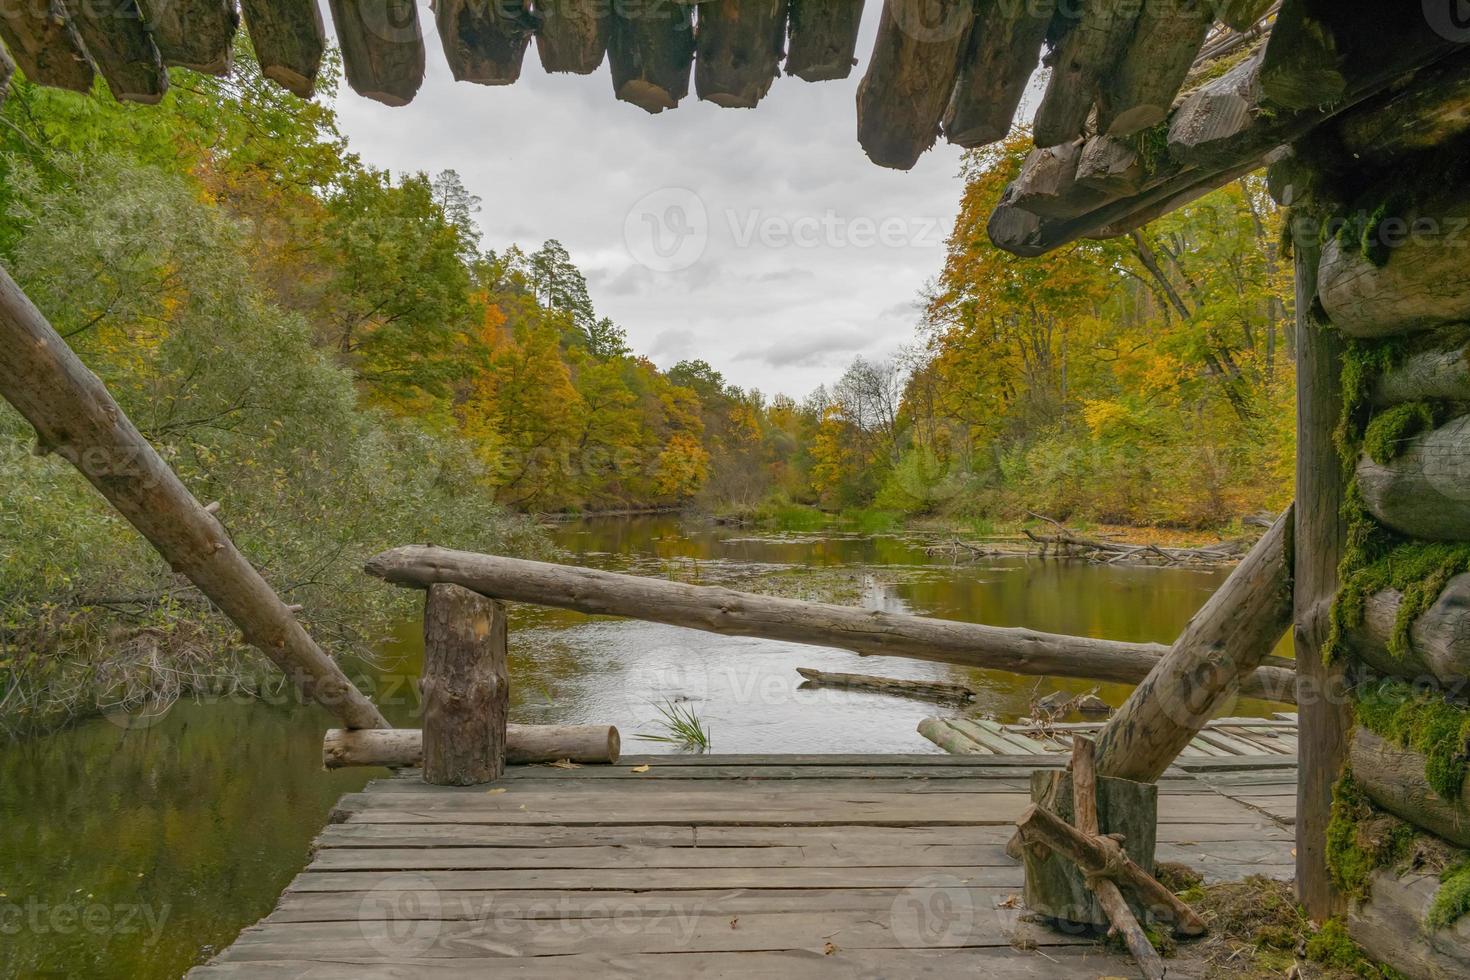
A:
[[333, 1, 1046, 397]]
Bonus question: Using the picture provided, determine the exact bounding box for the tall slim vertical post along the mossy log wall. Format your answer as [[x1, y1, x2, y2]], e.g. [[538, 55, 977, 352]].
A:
[[1292, 210, 1351, 920]]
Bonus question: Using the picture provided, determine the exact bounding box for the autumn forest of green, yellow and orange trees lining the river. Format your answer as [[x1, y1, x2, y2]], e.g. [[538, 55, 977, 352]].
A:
[[0, 49, 1292, 729]]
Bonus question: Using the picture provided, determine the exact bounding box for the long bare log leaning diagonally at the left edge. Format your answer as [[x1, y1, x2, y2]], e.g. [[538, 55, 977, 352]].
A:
[[0, 269, 388, 729]]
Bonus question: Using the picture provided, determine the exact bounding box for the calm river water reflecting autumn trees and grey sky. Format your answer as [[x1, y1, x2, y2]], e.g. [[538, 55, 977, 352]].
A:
[[0, 517, 1287, 977]]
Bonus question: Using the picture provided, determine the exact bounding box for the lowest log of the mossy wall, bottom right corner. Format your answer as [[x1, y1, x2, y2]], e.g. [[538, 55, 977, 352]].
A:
[[1347, 868, 1470, 980]]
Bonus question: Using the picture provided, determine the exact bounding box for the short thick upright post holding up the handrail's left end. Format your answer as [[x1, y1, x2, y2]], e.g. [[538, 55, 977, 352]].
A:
[[423, 585, 510, 786]]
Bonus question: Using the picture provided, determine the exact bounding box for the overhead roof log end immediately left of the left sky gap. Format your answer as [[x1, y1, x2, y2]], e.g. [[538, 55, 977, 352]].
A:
[[331, 0, 426, 106]]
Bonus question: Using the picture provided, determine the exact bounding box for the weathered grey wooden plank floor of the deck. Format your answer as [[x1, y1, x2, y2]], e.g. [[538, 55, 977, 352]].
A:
[[190, 755, 1295, 980]]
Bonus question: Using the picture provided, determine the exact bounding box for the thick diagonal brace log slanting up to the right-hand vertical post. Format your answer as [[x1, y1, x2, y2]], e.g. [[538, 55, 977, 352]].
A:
[[1098, 507, 1295, 783]]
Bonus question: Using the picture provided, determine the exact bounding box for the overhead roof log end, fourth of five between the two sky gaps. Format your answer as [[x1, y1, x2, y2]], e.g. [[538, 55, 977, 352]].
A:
[[694, 0, 786, 109]]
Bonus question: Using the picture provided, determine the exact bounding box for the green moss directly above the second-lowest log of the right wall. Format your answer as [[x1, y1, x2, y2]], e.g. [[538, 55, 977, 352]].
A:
[[1354, 679, 1470, 801]]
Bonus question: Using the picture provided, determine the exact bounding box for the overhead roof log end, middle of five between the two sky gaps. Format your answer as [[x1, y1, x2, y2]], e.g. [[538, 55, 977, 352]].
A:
[[607, 0, 694, 113]]
